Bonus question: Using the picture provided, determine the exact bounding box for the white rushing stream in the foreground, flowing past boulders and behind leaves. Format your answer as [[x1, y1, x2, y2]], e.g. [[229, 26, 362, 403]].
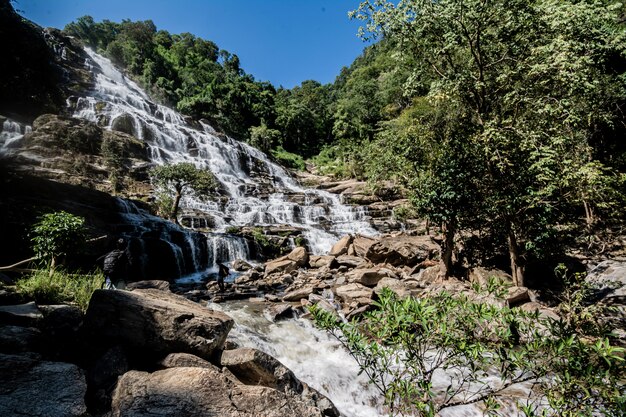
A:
[[208, 302, 531, 417]]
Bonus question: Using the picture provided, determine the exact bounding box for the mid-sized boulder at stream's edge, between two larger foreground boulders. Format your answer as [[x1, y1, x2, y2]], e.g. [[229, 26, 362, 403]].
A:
[[220, 348, 303, 394]]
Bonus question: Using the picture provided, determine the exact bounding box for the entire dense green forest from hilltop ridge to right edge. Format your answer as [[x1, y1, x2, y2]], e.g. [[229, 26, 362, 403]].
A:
[[65, 0, 626, 285]]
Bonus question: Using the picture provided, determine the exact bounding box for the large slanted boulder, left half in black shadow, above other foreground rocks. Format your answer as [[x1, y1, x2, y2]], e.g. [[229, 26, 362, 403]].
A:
[[84, 289, 234, 360]]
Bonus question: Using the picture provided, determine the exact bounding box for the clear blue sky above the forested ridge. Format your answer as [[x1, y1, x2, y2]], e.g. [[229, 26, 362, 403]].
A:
[[14, 0, 365, 88]]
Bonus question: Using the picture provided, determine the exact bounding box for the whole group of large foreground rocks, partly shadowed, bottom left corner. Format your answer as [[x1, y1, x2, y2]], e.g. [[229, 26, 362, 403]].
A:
[[0, 282, 339, 417]]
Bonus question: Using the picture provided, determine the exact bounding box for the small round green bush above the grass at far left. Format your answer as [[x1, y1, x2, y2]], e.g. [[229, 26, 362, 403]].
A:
[[30, 211, 85, 267]]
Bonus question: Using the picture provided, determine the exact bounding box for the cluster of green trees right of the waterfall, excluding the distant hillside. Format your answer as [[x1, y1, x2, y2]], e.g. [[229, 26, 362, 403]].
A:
[[353, 0, 626, 283]]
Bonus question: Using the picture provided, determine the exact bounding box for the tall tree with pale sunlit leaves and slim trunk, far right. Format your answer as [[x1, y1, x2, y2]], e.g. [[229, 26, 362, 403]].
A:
[[353, 0, 626, 285]]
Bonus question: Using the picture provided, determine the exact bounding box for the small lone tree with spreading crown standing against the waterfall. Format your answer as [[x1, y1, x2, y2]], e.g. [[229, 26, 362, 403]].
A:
[[150, 162, 218, 224]]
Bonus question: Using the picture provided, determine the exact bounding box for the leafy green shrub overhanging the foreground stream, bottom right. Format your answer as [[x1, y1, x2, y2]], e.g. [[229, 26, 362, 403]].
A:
[[311, 289, 625, 416]]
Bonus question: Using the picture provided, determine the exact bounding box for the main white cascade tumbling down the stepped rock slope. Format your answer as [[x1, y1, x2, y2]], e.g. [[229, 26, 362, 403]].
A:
[[74, 50, 376, 255]]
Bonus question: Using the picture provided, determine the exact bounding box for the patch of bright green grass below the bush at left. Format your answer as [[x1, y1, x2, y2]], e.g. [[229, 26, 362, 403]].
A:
[[15, 269, 104, 311]]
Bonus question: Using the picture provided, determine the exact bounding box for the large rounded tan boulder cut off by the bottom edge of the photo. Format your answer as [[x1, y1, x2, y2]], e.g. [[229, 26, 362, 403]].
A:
[[111, 368, 333, 417]]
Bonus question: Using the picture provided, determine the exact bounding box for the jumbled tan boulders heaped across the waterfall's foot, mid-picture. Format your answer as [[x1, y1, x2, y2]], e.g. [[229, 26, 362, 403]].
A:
[[207, 232, 530, 318]]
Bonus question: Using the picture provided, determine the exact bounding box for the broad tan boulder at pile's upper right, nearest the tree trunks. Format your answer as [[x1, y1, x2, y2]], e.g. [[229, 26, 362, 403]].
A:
[[365, 234, 439, 266]]
